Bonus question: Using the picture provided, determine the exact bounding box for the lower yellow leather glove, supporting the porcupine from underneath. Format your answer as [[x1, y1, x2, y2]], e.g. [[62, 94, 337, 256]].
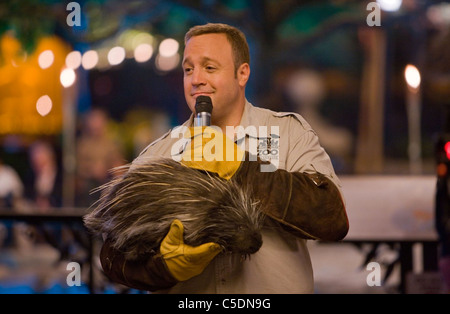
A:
[[160, 219, 222, 281]]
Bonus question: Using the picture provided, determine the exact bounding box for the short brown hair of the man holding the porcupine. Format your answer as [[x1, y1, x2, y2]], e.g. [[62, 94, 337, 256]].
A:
[[184, 23, 250, 71]]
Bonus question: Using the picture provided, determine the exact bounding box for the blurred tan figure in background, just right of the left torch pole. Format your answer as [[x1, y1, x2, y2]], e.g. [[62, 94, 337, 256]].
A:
[[76, 108, 125, 206]]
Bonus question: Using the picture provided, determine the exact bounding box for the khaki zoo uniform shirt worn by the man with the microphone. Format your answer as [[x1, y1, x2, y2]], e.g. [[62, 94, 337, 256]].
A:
[[135, 101, 342, 294]]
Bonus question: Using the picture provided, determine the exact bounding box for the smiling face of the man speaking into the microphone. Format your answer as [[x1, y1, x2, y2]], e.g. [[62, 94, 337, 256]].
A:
[[183, 34, 248, 124]]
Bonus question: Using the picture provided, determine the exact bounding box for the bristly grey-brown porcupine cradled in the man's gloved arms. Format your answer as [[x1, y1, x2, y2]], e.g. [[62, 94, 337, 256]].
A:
[[84, 158, 264, 260]]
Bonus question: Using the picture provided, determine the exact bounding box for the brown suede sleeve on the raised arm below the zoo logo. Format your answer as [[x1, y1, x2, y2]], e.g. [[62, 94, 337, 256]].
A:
[[235, 153, 349, 241]]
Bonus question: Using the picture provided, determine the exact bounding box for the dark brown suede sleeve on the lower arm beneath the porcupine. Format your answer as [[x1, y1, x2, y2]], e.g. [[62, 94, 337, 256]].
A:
[[100, 239, 177, 291]]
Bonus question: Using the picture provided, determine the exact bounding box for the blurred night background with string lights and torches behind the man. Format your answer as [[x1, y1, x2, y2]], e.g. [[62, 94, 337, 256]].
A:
[[0, 0, 450, 293]]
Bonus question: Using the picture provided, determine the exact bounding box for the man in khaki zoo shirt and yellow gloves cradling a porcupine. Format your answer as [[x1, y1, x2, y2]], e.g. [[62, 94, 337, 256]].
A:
[[101, 24, 348, 293]]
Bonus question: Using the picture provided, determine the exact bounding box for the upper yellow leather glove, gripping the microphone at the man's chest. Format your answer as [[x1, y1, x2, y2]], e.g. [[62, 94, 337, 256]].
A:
[[181, 126, 245, 180]]
